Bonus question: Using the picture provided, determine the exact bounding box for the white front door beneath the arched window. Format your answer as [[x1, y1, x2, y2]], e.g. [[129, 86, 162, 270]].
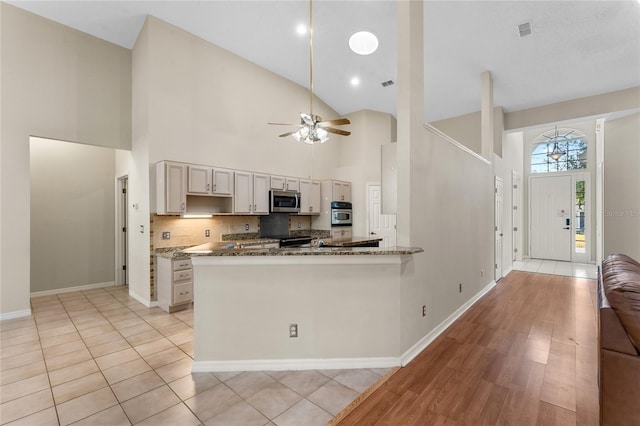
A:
[[529, 176, 572, 261]]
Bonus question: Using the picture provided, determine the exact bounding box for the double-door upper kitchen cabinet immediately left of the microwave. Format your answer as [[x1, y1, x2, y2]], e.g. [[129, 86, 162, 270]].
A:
[[233, 172, 269, 214]]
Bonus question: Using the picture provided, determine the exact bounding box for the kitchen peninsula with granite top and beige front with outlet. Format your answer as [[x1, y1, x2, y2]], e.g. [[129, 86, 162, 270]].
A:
[[173, 245, 423, 371]]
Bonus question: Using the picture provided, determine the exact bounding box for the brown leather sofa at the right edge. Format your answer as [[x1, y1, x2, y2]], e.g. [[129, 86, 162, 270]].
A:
[[598, 254, 640, 426]]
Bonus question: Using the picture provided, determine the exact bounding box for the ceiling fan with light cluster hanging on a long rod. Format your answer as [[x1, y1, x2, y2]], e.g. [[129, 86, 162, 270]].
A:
[[268, 0, 351, 144]]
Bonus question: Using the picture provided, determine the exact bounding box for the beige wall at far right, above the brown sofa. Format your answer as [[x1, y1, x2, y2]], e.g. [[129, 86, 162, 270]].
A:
[[603, 114, 640, 260]]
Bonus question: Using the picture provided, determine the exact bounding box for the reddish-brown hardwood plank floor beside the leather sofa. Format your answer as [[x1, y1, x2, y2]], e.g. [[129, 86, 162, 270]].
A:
[[337, 271, 599, 426]]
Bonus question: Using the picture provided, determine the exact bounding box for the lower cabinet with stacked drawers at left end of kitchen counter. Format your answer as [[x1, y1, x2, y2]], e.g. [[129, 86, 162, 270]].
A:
[[155, 257, 193, 312]]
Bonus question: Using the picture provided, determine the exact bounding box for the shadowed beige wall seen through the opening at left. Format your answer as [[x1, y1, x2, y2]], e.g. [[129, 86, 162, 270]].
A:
[[30, 138, 115, 293]]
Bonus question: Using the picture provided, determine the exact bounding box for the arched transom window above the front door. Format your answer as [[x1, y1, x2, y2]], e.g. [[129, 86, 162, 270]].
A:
[[531, 127, 587, 173]]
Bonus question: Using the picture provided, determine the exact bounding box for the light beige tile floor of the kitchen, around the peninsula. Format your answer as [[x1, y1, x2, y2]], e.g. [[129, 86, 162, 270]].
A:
[[0, 287, 387, 426]]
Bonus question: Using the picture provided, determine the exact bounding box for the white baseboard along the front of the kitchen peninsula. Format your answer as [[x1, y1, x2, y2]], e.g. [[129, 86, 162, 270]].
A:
[[191, 357, 400, 373]]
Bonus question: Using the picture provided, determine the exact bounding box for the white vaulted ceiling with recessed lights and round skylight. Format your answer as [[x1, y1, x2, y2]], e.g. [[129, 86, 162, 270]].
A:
[[6, 0, 640, 121]]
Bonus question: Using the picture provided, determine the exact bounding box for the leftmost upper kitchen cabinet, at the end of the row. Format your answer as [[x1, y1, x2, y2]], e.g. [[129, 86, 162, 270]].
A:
[[156, 161, 187, 214]]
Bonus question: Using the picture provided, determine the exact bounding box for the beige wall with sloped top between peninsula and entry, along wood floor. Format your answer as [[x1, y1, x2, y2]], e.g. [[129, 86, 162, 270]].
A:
[[398, 126, 493, 350]]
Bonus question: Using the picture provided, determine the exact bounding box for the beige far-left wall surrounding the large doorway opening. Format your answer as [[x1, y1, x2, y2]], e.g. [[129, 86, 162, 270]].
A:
[[0, 2, 131, 318]]
